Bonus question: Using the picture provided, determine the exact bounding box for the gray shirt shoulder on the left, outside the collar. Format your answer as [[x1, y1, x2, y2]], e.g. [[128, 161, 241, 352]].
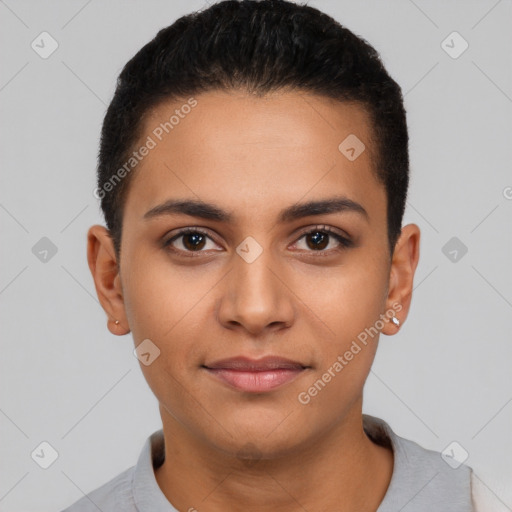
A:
[[61, 466, 137, 512]]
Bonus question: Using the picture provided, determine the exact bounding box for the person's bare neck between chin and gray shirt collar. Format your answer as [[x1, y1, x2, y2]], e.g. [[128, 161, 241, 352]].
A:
[[155, 401, 393, 512]]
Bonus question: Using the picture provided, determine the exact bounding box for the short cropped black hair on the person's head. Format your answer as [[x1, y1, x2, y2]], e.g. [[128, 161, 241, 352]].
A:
[[95, 0, 409, 257]]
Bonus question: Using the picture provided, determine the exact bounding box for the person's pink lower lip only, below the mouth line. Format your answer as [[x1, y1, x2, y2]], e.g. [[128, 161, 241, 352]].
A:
[[207, 368, 304, 393]]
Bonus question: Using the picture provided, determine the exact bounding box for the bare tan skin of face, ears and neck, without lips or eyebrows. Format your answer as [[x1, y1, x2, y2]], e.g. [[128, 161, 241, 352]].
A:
[[88, 91, 420, 512]]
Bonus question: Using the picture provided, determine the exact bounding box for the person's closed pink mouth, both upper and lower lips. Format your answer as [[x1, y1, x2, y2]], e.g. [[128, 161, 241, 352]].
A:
[[203, 356, 310, 393]]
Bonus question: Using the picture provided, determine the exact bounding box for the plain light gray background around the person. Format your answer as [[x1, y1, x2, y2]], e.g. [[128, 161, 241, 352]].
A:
[[0, 0, 512, 512]]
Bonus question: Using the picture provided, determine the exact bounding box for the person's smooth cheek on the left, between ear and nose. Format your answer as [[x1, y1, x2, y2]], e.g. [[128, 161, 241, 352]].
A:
[[123, 251, 214, 384]]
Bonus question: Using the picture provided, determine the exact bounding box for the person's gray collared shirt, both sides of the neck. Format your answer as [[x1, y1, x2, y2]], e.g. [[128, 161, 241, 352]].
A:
[[62, 414, 474, 512]]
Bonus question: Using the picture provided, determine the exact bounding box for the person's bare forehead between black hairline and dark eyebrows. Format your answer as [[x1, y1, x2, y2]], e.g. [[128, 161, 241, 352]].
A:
[[122, 91, 385, 224]]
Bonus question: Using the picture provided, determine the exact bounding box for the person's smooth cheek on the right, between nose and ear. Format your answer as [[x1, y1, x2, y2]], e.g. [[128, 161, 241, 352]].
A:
[[300, 255, 387, 392]]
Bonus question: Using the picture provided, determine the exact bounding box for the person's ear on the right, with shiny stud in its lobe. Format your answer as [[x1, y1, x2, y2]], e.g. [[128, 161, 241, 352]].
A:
[[382, 224, 420, 335]]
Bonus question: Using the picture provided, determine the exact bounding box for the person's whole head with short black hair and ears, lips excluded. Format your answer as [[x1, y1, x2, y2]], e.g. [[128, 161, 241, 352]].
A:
[[88, 0, 419, 457]]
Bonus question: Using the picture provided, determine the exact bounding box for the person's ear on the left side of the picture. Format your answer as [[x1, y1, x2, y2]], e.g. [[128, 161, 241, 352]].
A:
[[87, 225, 130, 336]]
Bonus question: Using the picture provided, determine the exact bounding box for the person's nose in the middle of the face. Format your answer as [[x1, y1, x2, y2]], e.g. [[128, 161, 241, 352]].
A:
[[218, 244, 295, 335]]
